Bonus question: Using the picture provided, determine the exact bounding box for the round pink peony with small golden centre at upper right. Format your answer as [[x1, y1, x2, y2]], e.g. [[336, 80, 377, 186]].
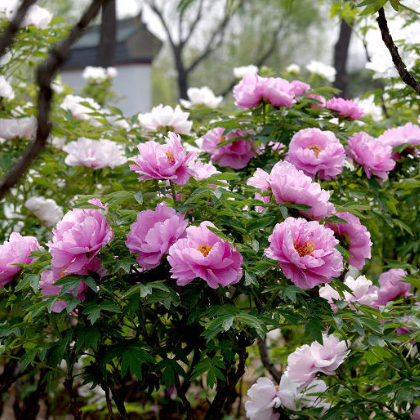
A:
[[286, 128, 345, 179]]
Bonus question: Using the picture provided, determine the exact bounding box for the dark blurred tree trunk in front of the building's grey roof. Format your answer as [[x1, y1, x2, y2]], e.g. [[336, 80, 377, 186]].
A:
[[95, 0, 117, 67]]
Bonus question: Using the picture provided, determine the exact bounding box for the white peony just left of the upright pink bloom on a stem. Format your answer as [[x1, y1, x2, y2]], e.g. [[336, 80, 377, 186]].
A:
[[63, 137, 127, 169]]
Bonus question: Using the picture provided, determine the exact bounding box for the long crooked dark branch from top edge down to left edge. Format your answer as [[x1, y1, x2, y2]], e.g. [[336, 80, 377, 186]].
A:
[[0, 0, 109, 200]]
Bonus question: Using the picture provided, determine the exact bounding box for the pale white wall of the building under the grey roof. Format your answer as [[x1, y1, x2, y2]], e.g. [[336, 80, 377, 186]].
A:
[[61, 64, 152, 117]]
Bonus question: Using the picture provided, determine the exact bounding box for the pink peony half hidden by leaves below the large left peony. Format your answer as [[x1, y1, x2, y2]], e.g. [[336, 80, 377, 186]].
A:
[[39, 257, 106, 313]]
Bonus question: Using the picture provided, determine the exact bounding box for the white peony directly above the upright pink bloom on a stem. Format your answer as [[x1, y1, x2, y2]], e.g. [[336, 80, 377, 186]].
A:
[[138, 105, 192, 134]]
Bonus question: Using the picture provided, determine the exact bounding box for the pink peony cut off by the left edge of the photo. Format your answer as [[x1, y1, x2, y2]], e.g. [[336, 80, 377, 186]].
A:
[[0, 232, 39, 287]]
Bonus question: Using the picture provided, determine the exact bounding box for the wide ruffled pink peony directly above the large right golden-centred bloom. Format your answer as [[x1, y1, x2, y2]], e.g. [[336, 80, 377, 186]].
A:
[[247, 162, 334, 220]]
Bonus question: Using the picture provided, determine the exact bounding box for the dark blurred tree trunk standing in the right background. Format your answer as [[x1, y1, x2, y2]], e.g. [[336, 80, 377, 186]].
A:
[[333, 19, 352, 98]]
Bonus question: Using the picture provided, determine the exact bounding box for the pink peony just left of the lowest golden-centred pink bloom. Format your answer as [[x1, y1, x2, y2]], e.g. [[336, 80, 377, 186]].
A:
[[125, 204, 188, 270]]
